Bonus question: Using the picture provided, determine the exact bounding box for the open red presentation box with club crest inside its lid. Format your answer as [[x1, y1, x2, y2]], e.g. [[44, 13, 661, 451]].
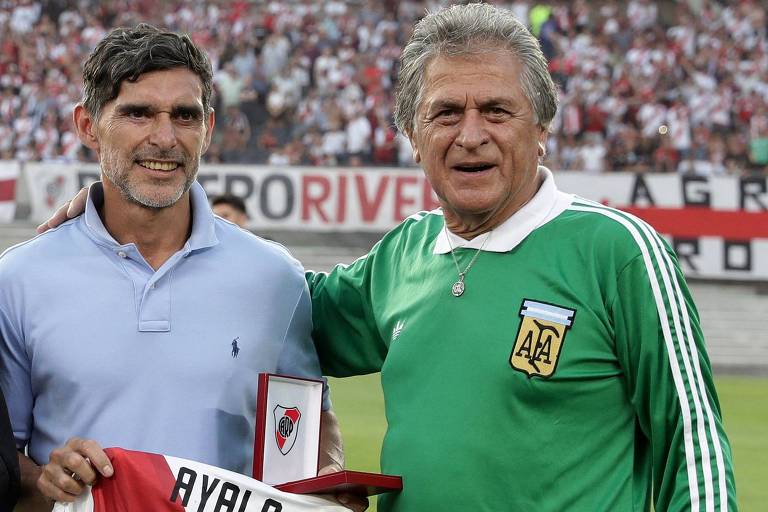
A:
[[253, 373, 403, 496]]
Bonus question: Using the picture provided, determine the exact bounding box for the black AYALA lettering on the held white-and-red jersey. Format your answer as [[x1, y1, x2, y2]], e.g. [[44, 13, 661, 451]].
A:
[[168, 466, 283, 512]]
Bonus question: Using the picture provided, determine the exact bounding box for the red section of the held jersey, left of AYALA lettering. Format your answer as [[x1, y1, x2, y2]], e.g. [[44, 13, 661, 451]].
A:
[[91, 448, 184, 512]]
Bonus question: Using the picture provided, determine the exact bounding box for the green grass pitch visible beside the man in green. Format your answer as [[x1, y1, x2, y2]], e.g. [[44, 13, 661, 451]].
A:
[[331, 374, 768, 512]]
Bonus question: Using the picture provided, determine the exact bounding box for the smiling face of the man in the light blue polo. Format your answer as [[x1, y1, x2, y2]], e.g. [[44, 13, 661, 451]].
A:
[[84, 68, 213, 209]]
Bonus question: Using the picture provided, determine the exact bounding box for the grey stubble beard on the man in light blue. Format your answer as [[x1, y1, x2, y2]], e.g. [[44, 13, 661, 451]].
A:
[[100, 146, 198, 210]]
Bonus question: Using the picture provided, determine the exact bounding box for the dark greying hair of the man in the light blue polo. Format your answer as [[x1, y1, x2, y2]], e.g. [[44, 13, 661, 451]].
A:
[[82, 23, 213, 119]]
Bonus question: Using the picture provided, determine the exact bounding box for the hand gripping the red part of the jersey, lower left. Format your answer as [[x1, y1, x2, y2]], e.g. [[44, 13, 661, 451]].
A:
[[37, 437, 114, 502]]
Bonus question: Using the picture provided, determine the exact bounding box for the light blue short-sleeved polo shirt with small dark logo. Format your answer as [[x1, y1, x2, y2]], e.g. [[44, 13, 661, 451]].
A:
[[0, 183, 329, 474]]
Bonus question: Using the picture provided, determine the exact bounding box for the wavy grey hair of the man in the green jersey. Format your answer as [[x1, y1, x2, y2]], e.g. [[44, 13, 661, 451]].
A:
[[394, 3, 557, 133]]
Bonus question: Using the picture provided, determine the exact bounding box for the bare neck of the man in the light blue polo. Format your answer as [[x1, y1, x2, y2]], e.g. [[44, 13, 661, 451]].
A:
[[99, 187, 192, 270]]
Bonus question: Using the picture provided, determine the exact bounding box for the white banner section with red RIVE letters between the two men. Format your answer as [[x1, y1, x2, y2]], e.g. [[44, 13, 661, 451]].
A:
[[198, 166, 437, 233]]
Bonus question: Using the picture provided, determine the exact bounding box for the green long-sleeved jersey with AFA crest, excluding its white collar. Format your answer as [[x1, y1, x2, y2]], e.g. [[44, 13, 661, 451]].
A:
[[307, 197, 737, 512]]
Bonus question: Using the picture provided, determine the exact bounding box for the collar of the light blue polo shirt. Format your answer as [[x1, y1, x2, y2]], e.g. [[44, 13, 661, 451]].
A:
[[84, 181, 219, 251]]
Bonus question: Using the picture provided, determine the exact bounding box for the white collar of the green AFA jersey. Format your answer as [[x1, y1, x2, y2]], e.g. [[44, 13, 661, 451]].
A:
[[432, 166, 573, 254]]
